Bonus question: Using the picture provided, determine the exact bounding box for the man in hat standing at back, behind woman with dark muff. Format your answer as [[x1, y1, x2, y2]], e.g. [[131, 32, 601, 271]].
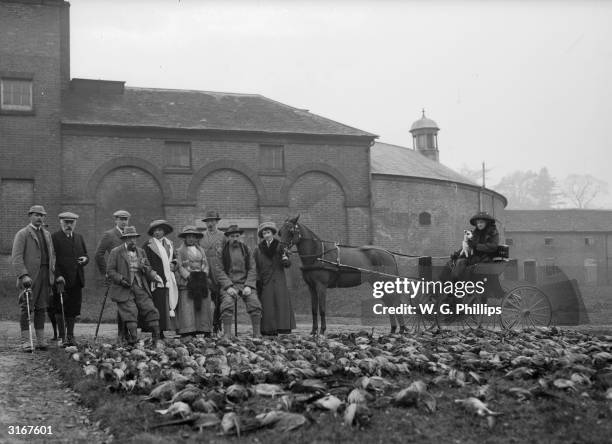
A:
[[200, 211, 227, 333]]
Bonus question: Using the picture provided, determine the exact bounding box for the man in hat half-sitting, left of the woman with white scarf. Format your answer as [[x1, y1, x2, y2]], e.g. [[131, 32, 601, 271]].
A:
[[106, 227, 163, 345]]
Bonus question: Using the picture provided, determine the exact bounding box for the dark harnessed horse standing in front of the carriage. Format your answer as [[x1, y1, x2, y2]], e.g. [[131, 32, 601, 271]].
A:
[[279, 214, 406, 335]]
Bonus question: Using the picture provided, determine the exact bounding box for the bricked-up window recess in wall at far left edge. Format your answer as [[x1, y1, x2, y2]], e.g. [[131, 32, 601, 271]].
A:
[[0, 179, 34, 253]]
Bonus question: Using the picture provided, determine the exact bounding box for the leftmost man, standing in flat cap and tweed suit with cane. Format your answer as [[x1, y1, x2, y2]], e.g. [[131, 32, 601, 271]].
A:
[[11, 205, 55, 351]]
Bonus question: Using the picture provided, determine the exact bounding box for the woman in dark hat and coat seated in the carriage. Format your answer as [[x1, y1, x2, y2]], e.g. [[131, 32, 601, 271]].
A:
[[451, 211, 499, 280]]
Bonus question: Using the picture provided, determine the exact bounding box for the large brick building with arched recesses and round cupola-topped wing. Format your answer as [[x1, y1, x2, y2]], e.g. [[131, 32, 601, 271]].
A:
[[0, 0, 506, 302]]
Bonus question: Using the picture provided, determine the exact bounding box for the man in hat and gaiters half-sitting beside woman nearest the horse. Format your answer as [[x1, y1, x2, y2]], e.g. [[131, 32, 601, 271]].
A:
[[214, 225, 261, 337]]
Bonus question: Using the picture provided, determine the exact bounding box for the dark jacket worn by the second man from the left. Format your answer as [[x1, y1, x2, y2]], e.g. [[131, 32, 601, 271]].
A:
[[51, 230, 89, 288]]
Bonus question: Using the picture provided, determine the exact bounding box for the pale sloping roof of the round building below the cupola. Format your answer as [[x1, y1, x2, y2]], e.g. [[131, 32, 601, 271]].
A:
[[370, 142, 477, 185]]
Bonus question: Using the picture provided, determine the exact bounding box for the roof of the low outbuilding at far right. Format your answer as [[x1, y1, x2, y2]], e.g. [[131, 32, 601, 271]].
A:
[[505, 209, 612, 232]]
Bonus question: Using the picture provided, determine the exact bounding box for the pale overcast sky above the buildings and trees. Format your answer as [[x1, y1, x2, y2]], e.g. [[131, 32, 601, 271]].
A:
[[70, 0, 612, 207]]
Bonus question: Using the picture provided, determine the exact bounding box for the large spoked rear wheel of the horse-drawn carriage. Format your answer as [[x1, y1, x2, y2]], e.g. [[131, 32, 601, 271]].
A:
[[501, 285, 552, 329]]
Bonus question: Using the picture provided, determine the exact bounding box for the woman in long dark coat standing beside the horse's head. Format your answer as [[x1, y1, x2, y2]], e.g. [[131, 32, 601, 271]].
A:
[[254, 222, 295, 336]]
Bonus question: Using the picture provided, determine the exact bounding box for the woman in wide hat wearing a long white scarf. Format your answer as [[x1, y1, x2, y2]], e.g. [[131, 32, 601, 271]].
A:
[[143, 220, 178, 339]]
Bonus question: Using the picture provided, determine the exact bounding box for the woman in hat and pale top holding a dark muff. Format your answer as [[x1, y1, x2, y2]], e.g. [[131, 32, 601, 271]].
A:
[[176, 225, 212, 336]]
